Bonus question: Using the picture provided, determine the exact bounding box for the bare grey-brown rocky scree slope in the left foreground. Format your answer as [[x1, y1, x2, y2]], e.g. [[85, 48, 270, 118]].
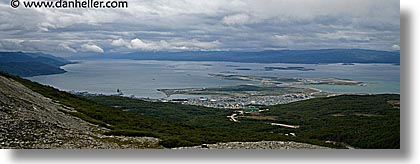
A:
[[0, 75, 159, 149]]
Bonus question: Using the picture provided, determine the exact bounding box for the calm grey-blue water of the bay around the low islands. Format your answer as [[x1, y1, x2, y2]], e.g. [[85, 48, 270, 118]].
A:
[[28, 59, 400, 98]]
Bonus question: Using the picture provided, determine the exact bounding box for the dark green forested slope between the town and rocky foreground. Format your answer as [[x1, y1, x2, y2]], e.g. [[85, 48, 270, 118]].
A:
[[89, 95, 400, 148]]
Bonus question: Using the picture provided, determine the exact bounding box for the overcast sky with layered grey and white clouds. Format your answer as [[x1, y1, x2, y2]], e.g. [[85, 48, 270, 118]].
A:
[[0, 0, 400, 56]]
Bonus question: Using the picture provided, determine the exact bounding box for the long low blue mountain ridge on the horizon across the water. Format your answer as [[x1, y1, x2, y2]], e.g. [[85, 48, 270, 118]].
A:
[[84, 49, 400, 64]]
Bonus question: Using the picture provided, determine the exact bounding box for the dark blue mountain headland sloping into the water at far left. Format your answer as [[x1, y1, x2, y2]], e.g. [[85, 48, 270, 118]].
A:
[[0, 52, 71, 77]]
